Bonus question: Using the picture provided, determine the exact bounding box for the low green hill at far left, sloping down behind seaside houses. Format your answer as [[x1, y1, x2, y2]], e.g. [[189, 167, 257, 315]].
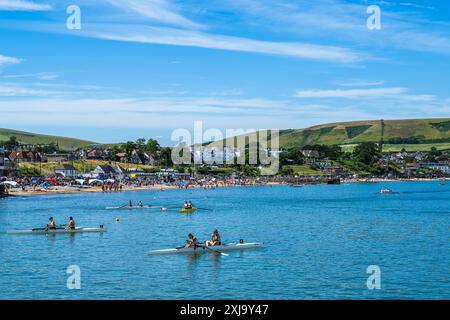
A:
[[0, 128, 94, 151]]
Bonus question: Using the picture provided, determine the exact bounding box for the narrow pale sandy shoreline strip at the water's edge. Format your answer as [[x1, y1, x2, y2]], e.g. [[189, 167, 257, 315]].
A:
[[9, 178, 450, 197]]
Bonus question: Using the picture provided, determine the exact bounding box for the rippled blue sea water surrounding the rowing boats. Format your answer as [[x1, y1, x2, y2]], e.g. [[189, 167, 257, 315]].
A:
[[0, 182, 450, 299]]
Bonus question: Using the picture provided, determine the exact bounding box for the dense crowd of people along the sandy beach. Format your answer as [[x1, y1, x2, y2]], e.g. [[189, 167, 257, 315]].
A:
[[0, 171, 446, 195]]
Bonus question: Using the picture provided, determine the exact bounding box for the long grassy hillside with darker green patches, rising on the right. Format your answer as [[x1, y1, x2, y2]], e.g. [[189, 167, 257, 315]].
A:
[[211, 118, 450, 149]]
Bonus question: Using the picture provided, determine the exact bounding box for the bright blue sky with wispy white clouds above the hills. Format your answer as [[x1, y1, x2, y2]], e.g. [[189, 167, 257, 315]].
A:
[[0, 0, 450, 144]]
